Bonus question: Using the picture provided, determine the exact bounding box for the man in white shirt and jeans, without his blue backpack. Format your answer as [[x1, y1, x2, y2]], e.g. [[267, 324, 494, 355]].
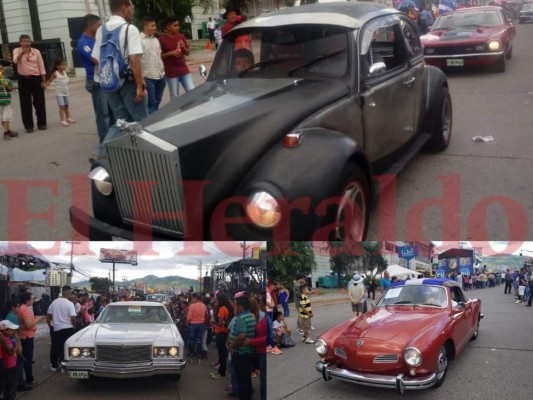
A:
[[91, 0, 148, 157]]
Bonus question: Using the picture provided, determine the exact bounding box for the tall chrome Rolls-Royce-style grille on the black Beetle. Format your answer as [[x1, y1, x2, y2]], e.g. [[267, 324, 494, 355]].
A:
[[106, 132, 185, 235]]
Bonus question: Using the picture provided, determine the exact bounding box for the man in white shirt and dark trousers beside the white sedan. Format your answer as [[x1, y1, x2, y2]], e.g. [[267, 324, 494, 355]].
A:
[[46, 285, 76, 372]]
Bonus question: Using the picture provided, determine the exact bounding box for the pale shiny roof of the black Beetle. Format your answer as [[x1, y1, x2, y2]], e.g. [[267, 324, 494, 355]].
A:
[[233, 1, 400, 31]]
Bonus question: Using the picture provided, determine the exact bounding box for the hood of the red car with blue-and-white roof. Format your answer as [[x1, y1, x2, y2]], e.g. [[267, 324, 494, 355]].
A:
[[341, 306, 446, 340]]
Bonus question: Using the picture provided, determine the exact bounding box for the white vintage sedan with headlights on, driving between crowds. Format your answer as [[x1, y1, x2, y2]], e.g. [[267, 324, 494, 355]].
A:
[[62, 301, 186, 380]]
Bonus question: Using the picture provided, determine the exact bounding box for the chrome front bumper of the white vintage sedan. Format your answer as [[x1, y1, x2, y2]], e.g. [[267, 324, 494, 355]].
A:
[[61, 360, 186, 379]]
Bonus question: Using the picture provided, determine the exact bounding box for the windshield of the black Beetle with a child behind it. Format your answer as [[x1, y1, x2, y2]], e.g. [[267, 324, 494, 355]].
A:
[[211, 25, 350, 79]]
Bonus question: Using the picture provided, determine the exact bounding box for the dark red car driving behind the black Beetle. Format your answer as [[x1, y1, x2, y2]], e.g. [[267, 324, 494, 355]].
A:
[[420, 6, 516, 72]]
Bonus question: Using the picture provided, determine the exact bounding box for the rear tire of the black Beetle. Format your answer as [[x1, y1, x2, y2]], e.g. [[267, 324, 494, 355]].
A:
[[426, 87, 453, 152]]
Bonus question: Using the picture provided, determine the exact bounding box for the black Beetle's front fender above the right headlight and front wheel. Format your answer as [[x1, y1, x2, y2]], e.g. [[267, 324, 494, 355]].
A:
[[238, 127, 372, 233]]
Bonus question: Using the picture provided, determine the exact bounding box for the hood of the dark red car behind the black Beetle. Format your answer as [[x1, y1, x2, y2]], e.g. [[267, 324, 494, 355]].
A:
[[420, 26, 505, 46]]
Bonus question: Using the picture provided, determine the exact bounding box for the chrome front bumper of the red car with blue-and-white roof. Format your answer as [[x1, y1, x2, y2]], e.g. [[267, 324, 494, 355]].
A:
[[316, 361, 437, 393]]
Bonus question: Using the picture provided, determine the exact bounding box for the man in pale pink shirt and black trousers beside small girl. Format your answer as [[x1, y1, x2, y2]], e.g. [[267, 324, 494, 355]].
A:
[[13, 35, 47, 133]]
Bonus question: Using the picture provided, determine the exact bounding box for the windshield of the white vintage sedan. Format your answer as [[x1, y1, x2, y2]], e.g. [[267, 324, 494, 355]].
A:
[[97, 305, 172, 324]]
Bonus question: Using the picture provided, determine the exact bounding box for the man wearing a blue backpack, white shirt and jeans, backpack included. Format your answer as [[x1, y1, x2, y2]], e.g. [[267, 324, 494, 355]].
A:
[[92, 0, 148, 157]]
